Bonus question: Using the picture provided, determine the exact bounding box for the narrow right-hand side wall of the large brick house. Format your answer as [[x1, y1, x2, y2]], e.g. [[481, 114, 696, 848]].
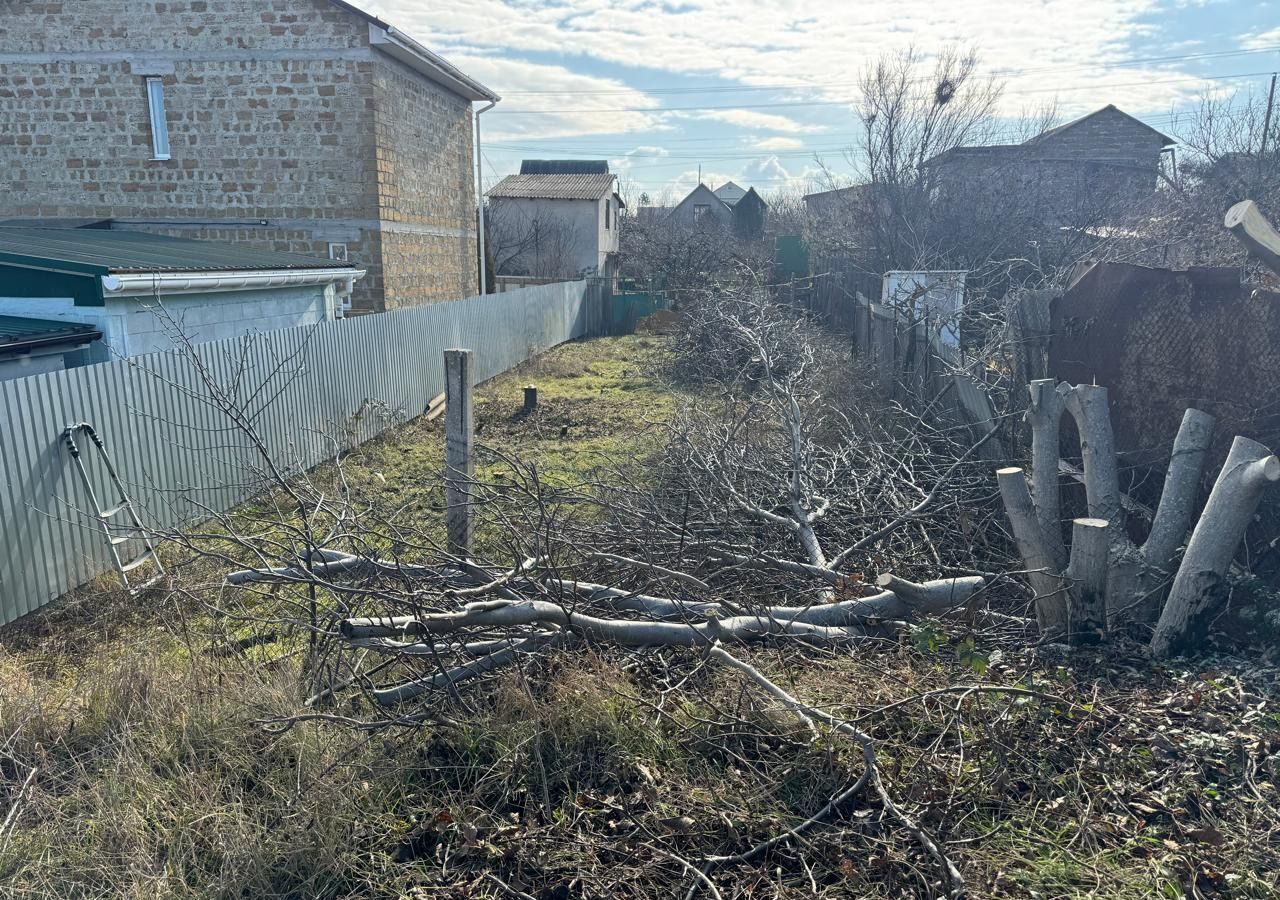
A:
[[374, 59, 479, 309]]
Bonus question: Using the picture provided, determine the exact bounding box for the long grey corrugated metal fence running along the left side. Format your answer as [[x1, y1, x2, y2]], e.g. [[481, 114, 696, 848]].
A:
[[0, 282, 605, 625]]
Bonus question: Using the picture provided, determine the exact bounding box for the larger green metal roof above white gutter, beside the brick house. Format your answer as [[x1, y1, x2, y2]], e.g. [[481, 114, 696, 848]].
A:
[[0, 227, 351, 275]]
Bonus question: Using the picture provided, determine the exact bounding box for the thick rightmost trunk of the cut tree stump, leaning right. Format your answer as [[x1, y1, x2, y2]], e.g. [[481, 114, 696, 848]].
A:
[[1151, 438, 1280, 657]]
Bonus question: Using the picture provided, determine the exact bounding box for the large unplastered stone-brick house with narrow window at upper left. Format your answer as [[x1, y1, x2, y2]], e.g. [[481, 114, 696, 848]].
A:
[[0, 0, 497, 311]]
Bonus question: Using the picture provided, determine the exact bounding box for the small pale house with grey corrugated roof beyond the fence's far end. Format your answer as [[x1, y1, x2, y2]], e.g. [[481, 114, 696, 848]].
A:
[[485, 172, 622, 278]]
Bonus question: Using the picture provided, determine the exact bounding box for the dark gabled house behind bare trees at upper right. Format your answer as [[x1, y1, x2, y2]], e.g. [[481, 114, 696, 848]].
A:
[[924, 106, 1174, 221]]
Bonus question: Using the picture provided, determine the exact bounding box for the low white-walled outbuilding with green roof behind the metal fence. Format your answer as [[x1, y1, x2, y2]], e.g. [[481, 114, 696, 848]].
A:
[[0, 228, 365, 376]]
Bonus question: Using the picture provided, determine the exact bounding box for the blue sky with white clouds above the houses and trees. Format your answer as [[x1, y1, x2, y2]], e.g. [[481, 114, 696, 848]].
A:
[[345, 0, 1280, 202]]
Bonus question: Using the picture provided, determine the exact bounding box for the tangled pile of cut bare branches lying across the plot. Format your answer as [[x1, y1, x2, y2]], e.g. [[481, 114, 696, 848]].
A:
[[175, 279, 1028, 896]]
